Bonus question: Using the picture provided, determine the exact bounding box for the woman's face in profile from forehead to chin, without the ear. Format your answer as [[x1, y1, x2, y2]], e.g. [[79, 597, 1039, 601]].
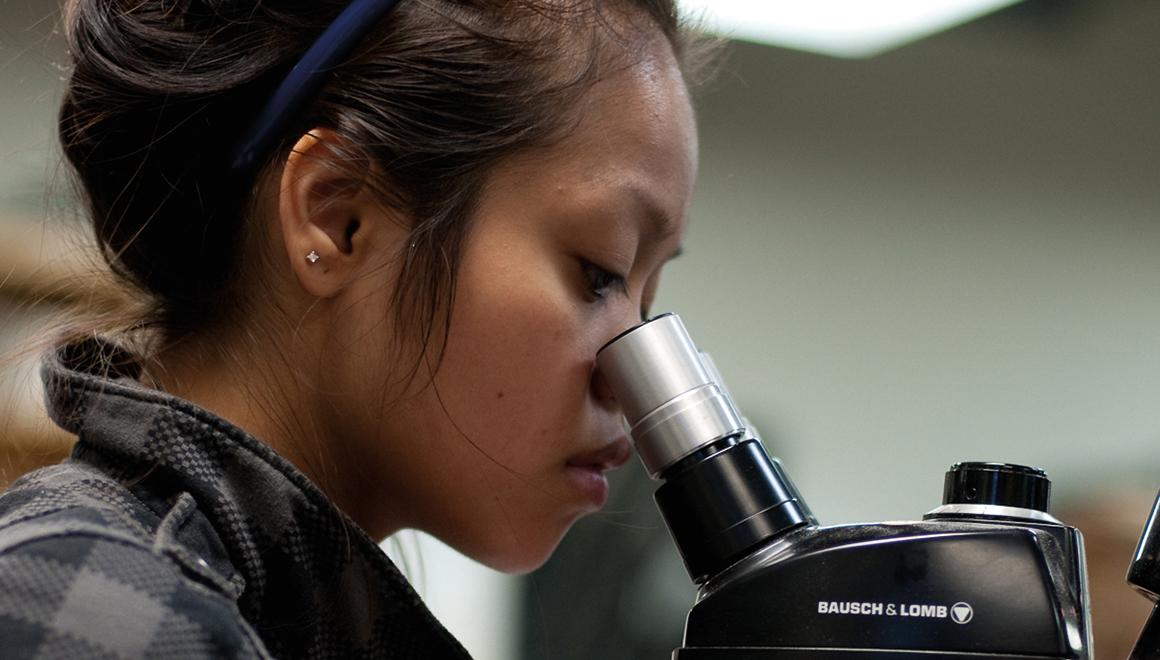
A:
[[346, 37, 697, 572]]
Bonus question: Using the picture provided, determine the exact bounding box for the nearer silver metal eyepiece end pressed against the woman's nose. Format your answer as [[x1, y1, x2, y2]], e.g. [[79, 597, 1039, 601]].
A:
[[596, 314, 745, 479]]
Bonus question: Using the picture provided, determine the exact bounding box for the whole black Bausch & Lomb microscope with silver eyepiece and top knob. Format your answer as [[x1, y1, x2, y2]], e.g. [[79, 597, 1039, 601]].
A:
[[596, 314, 1090, 660]]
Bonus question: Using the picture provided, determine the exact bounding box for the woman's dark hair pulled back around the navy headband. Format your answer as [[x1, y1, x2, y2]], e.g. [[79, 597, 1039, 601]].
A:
[[59, 0, 705, 347]]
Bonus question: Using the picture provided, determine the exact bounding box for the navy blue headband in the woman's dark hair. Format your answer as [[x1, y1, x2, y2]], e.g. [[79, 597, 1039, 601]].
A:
[[230, 0, 398, 177]]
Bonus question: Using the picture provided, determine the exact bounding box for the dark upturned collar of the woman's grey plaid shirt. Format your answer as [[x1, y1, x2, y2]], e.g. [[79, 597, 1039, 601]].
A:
[[42, 338, 465, 657]]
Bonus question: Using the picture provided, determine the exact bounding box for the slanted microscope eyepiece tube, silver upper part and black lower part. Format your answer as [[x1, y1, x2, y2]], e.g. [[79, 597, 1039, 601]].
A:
[[596, 314, 815, 583]]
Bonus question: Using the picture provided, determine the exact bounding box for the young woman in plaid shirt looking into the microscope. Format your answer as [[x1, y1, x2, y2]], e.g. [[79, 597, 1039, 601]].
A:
[[0, 0, 697, 658]]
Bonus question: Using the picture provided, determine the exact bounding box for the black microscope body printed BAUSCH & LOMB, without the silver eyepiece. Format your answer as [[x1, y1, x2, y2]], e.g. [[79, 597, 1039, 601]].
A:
[[657, 433, 1090, 660]]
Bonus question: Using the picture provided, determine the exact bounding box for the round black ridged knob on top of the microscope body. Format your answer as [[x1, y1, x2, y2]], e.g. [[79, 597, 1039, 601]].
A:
[[943, 463, 1051, 513]]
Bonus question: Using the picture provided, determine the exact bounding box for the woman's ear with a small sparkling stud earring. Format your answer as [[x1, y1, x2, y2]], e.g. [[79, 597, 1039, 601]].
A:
[[278, 129, 406, 298]]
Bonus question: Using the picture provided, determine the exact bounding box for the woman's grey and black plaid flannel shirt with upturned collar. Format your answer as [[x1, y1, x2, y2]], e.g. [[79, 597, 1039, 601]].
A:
[[0, 340, 467, 659]]
